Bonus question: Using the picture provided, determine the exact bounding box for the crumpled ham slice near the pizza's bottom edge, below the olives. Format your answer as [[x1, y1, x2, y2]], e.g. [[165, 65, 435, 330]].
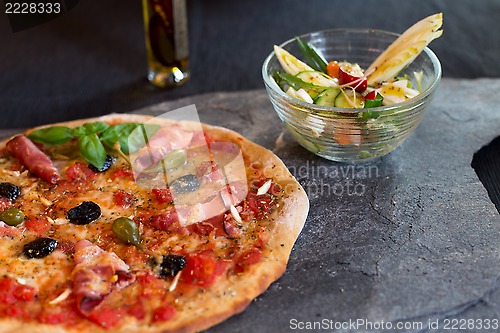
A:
[[72, 240, 135, 315]]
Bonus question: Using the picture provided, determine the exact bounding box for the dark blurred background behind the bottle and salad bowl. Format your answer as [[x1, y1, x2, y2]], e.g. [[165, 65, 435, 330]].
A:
[[0, 0, 500, 128]]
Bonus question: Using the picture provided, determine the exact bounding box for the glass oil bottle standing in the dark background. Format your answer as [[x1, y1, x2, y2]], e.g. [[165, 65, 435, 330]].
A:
[[142, 0, 190, 88]]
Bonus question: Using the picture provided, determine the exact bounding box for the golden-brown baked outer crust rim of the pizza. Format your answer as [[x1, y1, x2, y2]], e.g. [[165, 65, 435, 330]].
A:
[[0, 114, 309, 333]]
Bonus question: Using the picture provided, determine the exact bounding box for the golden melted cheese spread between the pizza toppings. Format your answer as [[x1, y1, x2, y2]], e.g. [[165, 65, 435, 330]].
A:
[[0, 125, 284, 330]]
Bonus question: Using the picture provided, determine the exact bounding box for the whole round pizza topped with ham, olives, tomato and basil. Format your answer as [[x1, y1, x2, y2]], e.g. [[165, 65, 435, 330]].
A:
[[0, 114, 309, 333]]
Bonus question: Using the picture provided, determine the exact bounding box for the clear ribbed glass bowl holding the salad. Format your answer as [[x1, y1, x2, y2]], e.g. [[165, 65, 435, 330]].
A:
[[262, 29, 441, 162]]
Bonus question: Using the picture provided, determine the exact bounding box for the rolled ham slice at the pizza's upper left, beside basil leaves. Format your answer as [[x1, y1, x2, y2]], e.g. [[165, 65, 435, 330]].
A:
[[7, 135, 61, 184]]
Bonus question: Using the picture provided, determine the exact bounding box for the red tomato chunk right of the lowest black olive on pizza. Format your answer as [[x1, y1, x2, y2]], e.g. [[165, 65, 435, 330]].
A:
[[181, 253, 227, 288]]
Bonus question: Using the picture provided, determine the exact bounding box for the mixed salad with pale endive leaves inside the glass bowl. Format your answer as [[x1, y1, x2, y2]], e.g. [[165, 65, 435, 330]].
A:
[[273, 13, 443, 108]]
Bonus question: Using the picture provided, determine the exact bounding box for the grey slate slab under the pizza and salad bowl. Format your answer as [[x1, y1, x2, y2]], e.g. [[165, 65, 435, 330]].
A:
[[0, 79, 500, 333]]
